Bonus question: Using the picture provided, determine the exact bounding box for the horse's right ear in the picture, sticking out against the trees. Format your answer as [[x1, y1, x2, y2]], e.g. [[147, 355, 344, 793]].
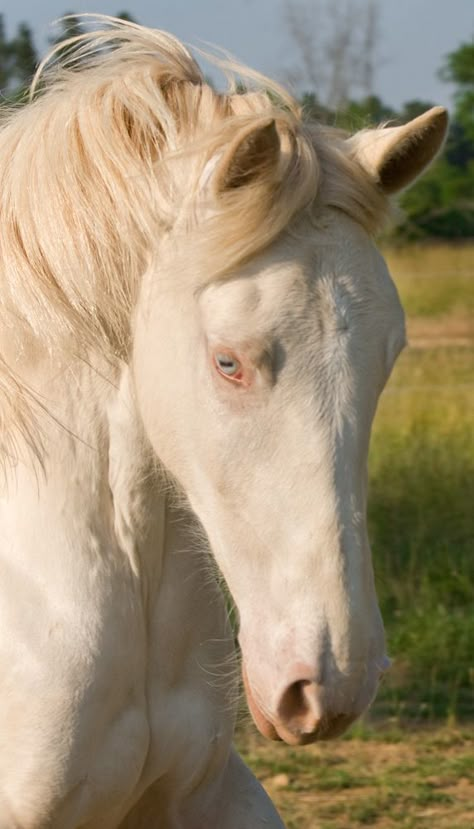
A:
[[349, 107, 448, 195]]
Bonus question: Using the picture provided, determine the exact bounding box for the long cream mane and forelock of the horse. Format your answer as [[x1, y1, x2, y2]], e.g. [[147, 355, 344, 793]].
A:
[[0, 18, 387, 460]]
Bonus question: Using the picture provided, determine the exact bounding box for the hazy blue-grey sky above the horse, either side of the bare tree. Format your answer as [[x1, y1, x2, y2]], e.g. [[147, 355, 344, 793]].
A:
[[0, 0, 474, 107]]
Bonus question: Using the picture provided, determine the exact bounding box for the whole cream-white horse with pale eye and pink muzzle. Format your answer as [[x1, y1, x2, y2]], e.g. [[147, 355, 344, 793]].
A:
[[0, 14, 446, 829]]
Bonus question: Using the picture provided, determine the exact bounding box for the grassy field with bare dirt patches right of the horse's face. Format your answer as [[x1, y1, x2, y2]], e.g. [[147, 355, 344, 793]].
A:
[[239, 246, 474, 829]]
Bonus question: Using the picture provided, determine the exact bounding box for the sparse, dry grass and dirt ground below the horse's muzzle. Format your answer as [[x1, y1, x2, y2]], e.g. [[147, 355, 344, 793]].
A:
[[240, 726, 474, 829]]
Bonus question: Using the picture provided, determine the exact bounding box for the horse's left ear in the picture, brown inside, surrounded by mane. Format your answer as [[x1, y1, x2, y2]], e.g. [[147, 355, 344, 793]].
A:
[[213, 118, 280, 194]]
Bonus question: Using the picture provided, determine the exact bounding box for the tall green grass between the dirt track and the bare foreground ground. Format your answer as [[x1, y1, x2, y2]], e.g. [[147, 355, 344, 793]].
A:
[[369, 347, 474, 718]]
